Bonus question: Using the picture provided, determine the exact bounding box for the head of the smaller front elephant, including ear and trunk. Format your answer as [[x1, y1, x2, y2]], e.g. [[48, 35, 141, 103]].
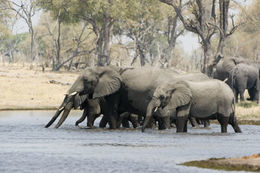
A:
[[142, 81, 192, 131]]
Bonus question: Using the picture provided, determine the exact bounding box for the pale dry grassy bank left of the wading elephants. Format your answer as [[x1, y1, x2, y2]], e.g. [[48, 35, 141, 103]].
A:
[[0, 64, 78, 110]]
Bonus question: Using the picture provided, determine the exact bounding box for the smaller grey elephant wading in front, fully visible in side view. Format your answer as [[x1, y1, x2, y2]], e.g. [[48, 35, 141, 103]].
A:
[[142, 79, 241, 133]]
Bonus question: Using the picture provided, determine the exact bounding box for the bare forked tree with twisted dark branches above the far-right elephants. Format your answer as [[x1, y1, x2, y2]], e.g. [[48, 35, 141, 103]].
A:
[[160, 0, 241, 74]]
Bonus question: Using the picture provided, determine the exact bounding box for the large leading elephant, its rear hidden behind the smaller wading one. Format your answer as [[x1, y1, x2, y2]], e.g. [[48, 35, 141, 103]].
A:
[[46, 66, 208, 129]]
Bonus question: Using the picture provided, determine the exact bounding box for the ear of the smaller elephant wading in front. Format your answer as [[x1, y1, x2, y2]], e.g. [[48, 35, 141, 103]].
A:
[[168, 81, 192, 109]]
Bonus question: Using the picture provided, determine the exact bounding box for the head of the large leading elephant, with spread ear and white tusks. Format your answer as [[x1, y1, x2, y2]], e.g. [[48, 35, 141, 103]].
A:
[[45, 67, 121, 128]]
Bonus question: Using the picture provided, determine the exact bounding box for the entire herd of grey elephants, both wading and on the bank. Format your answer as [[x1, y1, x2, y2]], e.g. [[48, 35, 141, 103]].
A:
[[45, 57, 260, 133]]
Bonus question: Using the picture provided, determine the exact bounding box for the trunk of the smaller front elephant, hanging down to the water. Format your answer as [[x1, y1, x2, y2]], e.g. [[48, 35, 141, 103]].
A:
[[142, 98, 161, 132]]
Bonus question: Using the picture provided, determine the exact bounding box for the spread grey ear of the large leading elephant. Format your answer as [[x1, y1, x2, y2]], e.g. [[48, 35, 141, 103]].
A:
[[93, 70, 122, 98]]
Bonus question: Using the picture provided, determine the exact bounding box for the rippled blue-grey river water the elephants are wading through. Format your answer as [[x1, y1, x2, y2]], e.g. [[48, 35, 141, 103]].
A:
[[0, 111, 260, 173]]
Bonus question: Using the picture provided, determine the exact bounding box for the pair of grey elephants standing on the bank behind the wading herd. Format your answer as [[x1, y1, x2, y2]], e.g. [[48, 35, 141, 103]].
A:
[[213, 57, 259, 102]]
